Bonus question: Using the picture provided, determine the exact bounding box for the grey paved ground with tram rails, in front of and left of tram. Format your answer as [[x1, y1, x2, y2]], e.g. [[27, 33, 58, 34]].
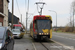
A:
[[14, 34, 71, 50]]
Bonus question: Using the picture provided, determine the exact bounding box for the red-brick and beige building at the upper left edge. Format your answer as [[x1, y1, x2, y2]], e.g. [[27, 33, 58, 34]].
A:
[[0, 0, 9, 26]]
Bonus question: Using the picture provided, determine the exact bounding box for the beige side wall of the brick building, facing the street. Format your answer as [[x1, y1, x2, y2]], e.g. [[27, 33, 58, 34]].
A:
[[3, 0, 8, 26]]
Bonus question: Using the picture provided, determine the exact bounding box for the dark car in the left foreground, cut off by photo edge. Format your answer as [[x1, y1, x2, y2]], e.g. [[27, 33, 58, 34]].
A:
[[0, 27, 14, 50]]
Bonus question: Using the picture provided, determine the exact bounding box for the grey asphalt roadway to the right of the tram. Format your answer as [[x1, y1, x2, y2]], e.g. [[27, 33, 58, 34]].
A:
[[52, 32, 75, 48]]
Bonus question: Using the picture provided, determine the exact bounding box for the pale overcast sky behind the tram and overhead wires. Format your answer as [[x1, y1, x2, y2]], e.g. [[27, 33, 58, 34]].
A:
[[9, 0, 73, 28]]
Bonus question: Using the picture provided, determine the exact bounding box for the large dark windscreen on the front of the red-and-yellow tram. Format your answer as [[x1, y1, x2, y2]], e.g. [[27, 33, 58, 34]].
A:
[[37, 20, 50, 29]]
